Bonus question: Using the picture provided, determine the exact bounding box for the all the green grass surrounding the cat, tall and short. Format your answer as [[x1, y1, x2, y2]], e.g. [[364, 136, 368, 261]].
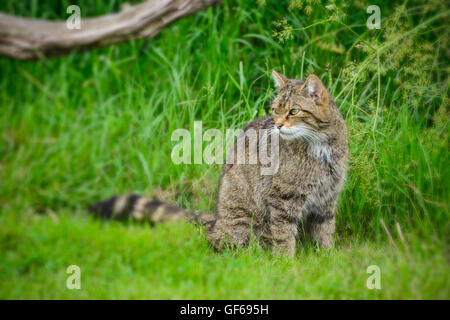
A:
[[0, 0, 450, 299]]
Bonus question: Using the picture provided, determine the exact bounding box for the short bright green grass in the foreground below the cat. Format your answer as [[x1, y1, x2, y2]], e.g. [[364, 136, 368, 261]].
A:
[[0, 213, 450, 299]]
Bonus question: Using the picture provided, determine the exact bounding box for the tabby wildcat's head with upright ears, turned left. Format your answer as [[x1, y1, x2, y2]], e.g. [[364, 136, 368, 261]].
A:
[[272, 70, 333, 142]]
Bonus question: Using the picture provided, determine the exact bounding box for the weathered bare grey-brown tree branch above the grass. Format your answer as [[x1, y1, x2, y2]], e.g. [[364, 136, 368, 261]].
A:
[[0, 0, 222, 60]]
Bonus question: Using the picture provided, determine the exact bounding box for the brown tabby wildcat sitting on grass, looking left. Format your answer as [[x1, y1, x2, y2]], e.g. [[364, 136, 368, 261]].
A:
[[90, 70, 348, 256]]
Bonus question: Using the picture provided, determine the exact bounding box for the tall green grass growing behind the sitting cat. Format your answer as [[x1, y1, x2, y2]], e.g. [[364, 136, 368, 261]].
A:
[[0, 1, 449, 237]]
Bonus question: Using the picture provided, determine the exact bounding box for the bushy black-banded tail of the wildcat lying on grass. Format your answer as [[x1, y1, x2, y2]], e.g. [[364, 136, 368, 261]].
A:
[[89, 194, 216, 230]]
